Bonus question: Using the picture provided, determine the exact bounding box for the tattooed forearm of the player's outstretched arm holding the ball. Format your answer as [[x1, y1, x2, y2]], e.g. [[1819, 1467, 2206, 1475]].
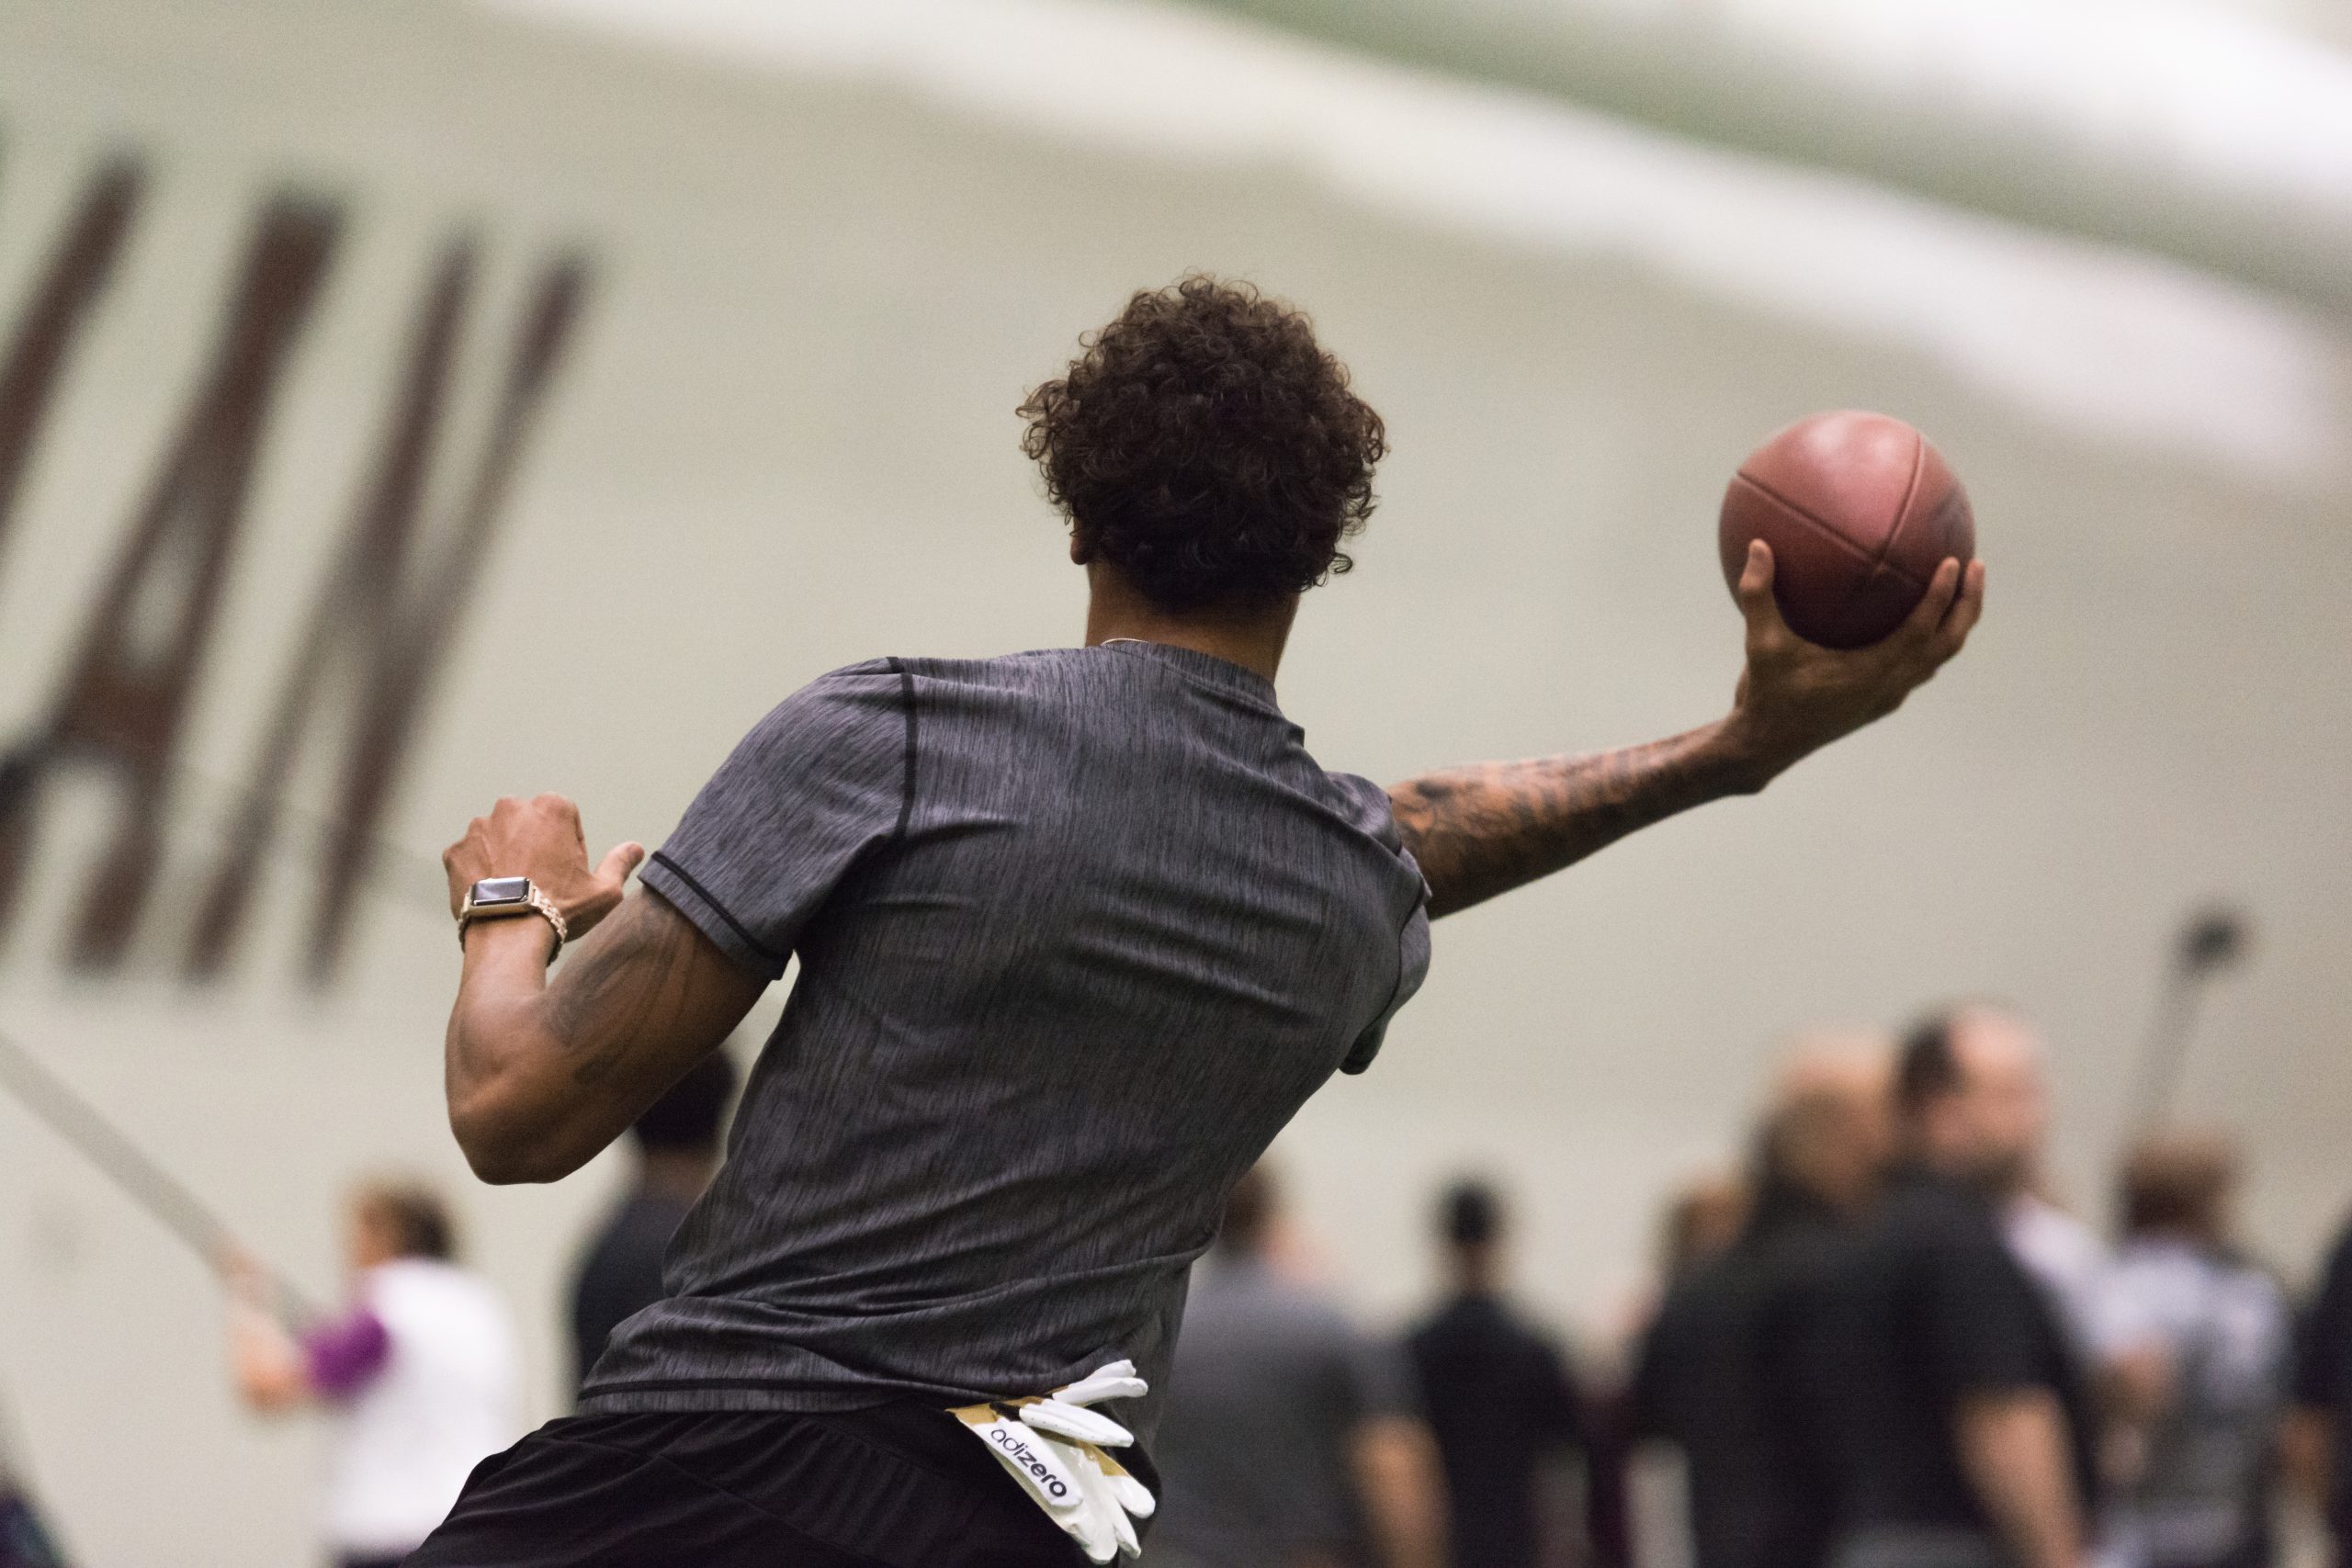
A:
[[1387, 724, 1761, 917]]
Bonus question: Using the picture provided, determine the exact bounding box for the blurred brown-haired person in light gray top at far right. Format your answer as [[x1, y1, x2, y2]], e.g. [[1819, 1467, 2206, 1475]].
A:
[[2105, 1134, 2293, 1568]]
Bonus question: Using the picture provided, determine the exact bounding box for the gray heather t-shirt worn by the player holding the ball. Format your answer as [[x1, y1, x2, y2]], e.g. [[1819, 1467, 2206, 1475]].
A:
[[581, 642, 1430, 1437]]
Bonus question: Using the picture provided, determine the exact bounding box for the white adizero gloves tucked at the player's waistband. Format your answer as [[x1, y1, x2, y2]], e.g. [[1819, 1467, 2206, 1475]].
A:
[[950, 1361, 1158, 1563]]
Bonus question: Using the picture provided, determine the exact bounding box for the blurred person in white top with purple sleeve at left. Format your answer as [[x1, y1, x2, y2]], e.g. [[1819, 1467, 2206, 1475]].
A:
[[228, 1182, 522, 1568]]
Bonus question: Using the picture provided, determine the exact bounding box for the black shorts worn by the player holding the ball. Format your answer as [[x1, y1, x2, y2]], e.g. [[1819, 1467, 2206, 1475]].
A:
[[407, 1404, 1087, 1568]]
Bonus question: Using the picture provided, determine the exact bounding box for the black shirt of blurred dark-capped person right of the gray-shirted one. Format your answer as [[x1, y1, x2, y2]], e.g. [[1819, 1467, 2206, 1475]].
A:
[[1407, 1295, 1588, 1568]]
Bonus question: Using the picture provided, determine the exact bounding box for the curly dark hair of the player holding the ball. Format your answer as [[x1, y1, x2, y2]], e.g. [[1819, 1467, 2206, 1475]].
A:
[[1021, 275, 1387, 616]]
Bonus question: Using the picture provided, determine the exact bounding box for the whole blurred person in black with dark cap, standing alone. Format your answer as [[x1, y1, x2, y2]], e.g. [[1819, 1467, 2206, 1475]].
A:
[[1407, 1180, 1595, 1568]]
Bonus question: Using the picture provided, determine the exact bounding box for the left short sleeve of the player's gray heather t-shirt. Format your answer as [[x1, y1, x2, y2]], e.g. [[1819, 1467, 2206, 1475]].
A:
[[642, 660, 915, 980]]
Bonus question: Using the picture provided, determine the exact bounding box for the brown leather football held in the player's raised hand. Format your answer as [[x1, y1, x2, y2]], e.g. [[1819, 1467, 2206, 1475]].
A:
[[1717, 409, 1975, 649]]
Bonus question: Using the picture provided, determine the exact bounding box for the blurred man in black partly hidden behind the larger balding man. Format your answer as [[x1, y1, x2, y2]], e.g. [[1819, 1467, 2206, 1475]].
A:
[[1633, 1039, 1894, 1568]]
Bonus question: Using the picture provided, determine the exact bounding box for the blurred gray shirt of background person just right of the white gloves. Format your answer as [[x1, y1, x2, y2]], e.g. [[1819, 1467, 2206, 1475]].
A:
[[1148, 1256, 1411, 1568]]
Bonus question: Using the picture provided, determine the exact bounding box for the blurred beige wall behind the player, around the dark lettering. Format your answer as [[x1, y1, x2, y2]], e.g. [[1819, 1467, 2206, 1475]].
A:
[[0, 0, 2352, 1568]]
